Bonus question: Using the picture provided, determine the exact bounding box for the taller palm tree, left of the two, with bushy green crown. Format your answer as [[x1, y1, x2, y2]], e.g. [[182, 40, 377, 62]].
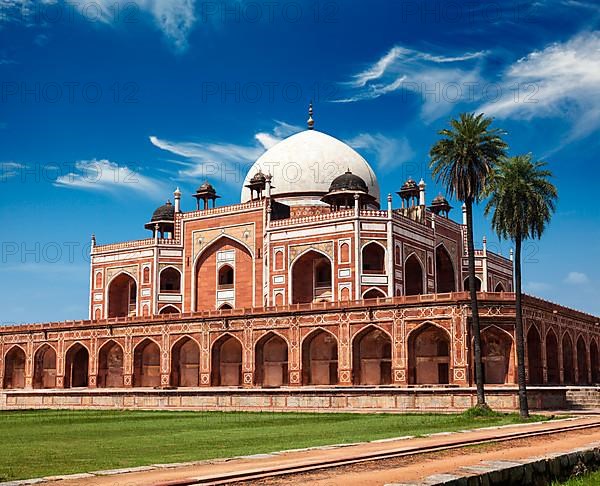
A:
[[429, 113, 507, 408]]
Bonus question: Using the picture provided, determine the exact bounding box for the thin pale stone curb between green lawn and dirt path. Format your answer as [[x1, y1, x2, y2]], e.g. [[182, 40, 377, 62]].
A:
[[0, 416, 583, 486]]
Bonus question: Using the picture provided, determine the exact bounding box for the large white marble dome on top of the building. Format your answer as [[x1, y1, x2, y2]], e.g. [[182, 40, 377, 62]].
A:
[[241, 130, 379, 205]]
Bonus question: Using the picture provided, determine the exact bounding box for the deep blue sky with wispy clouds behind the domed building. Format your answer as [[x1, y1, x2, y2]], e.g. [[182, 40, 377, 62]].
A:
[[0, 0, 600, 323]]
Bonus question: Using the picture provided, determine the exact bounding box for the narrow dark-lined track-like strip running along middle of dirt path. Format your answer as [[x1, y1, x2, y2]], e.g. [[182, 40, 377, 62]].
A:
[[160, 422, 600, 486]]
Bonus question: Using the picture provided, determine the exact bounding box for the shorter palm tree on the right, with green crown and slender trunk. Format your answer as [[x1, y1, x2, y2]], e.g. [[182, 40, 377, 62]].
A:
[[485, 154, 557, 418]]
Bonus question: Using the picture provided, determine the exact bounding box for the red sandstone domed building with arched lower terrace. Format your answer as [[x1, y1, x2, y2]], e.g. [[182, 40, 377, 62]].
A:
[[0, 122, 600, 389]]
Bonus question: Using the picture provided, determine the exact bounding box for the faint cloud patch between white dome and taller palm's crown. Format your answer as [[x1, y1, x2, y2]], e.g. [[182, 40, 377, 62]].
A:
[[346, 133, 415, 170]]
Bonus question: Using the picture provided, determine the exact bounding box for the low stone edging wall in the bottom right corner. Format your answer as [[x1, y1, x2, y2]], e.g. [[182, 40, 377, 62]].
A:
[[385, 442, 600, 486]]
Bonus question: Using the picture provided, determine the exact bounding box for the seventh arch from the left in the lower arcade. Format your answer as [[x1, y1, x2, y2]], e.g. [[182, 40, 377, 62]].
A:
[[210, 333, 243, 386]]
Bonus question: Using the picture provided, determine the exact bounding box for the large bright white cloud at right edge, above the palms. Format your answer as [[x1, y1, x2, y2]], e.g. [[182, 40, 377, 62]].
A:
[[480, 31, 600, 140]]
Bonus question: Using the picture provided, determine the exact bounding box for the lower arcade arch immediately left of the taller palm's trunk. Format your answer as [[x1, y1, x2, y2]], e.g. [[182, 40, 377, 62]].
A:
[[408, 324, 450, 385]]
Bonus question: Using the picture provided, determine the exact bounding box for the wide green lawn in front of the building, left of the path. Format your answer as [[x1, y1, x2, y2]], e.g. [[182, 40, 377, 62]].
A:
[[0, 410, 542, 481]]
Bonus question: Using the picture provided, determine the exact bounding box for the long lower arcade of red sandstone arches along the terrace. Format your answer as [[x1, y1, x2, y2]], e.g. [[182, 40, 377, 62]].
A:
[[0, 304, 600, 389]]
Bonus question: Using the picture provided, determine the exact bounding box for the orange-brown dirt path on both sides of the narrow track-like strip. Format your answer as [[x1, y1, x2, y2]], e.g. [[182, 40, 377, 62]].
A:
[[46, 417, 600, 486]]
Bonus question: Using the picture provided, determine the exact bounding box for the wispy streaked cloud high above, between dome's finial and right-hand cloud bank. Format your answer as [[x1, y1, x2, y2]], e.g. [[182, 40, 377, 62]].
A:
[[334, 46, 487, 121]]
